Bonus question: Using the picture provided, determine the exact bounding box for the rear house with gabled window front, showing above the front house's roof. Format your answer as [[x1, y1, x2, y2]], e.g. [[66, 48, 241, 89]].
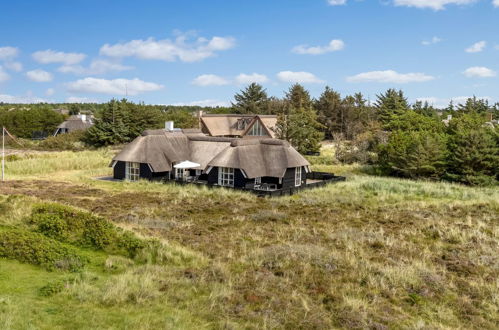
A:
[[198, 111, 277, 138]]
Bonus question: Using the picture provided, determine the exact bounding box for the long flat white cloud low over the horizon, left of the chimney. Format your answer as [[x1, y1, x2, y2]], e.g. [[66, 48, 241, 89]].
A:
[[67, 77, 164, 95]]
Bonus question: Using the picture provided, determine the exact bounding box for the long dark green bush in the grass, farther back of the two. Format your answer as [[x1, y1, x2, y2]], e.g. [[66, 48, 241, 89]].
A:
[[28, 203, 146, 258]]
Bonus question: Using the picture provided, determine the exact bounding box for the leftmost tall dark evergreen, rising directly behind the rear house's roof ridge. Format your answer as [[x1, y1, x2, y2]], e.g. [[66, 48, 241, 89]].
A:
[[232, 83, 269, 114]]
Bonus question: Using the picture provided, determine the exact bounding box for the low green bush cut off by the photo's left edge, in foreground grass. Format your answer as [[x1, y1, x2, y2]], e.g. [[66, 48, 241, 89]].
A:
[[0, 229, 87, 271]]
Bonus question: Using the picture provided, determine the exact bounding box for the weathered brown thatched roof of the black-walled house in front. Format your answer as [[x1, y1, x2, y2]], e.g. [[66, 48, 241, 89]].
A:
[[113, 130, 310, 178]]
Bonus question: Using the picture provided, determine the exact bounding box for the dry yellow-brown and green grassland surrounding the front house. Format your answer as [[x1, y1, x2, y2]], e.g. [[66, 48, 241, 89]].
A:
[[0, 150, 499, 329]]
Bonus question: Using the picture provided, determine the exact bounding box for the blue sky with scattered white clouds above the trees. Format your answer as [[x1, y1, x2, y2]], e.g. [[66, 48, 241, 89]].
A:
[[0, 0, 499, 106]]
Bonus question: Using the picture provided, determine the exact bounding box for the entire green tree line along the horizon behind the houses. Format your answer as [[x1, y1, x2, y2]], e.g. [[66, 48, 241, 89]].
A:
[[0, 83, 499, 184]]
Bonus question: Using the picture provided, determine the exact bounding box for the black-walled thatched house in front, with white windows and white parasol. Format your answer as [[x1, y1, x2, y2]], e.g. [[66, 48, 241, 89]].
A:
[[110, 130, 310, 190]]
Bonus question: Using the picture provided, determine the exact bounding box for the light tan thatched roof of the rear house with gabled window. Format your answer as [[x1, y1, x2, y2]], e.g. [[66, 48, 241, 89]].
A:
[[201, 114, 277, 137]]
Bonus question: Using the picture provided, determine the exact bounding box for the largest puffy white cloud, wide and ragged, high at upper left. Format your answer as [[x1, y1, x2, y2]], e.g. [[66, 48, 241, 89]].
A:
[[100, 34, 235, 62]]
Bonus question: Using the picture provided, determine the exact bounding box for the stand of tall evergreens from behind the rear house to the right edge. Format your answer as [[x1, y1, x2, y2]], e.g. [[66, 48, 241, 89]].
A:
[[232, 84, 499, 185]]
